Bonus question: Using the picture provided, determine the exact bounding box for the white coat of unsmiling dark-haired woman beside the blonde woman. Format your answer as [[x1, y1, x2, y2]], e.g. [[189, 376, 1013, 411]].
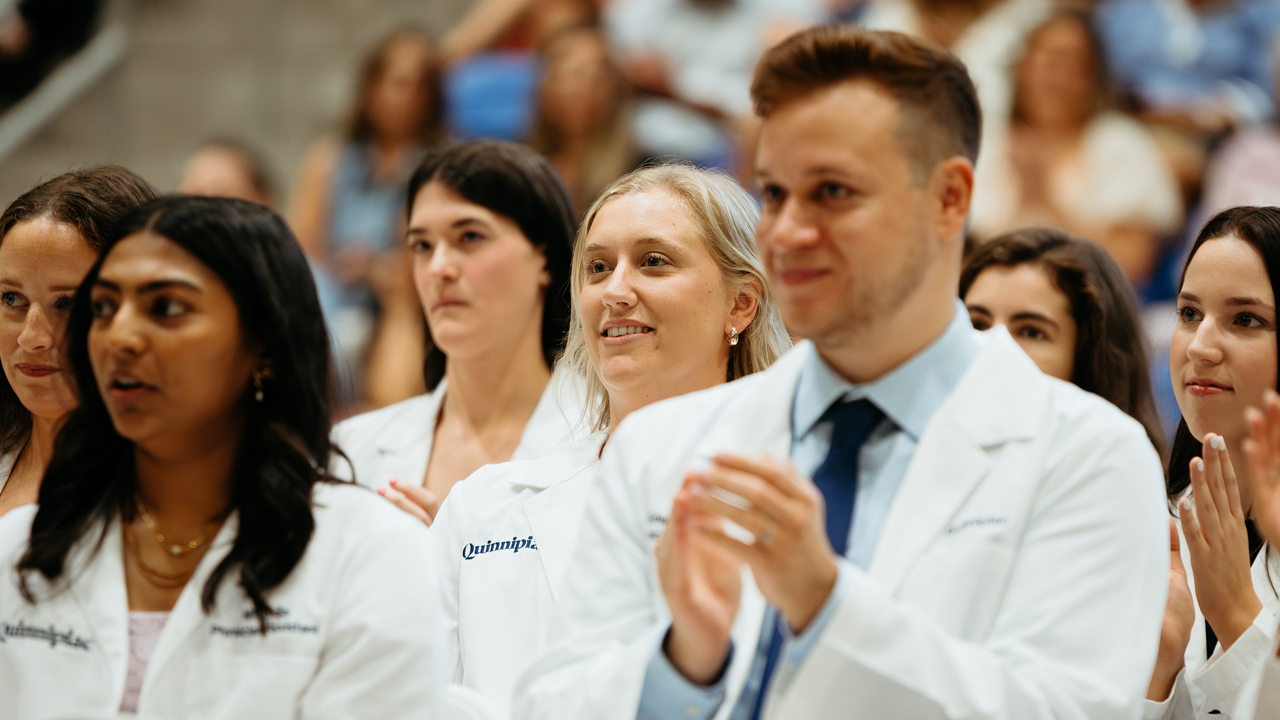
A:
[[332, 370, 585, 489]]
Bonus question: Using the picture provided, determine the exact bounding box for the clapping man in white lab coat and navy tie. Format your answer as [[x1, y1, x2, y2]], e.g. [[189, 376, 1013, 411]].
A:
[[516, 27, 1169, 720]]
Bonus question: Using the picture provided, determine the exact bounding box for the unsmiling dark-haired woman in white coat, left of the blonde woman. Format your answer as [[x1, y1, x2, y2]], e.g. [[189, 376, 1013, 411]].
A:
[[334, 141, 581, 524]]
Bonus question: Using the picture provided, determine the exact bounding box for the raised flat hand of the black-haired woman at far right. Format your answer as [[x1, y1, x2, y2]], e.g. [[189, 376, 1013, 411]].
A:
[[1178, 433, 1262, 648]]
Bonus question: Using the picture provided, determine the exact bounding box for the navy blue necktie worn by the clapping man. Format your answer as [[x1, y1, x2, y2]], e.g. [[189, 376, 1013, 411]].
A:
[[751, 400, 884, 720]]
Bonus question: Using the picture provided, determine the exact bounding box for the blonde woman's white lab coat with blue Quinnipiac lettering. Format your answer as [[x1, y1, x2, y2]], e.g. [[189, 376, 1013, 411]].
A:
[[431, 432, 607, 708]]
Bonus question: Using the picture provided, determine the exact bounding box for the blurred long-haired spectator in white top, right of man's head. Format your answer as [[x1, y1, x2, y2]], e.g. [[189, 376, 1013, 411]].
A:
[[973, 13, 1181, 286]]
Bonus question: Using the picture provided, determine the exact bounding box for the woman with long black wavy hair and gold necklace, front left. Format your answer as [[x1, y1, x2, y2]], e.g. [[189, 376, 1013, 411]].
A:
[[0, 197, 443, 719]]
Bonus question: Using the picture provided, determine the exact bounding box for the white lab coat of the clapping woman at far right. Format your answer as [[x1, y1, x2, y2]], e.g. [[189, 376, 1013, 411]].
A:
[[1143, 523, 1280, 720]]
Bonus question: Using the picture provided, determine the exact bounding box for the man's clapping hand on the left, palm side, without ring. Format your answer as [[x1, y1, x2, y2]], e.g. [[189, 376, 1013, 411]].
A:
[[654, 473, 742, 685]]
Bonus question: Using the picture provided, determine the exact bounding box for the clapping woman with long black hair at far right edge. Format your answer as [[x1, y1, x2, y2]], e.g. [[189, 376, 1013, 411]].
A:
[[1146, 208, 1280, 720]]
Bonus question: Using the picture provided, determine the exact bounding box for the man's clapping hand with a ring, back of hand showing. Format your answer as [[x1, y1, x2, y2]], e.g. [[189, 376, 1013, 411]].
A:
[[690, 455, 838, 633]]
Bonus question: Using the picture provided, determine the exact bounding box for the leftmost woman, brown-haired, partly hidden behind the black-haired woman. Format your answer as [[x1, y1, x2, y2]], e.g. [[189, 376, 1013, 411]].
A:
[[0, 165, 156, 515]]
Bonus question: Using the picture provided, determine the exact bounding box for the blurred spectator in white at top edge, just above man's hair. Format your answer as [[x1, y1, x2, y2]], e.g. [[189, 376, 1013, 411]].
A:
[[861, 0, 1051, 208]]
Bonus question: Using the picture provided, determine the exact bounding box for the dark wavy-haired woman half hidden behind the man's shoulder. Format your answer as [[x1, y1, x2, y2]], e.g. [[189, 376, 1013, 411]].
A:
[[960, 228, 1165, 450]]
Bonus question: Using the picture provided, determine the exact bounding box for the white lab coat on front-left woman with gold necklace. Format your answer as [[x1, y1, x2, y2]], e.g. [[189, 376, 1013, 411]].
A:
[[0, 483, 447, 720]]
